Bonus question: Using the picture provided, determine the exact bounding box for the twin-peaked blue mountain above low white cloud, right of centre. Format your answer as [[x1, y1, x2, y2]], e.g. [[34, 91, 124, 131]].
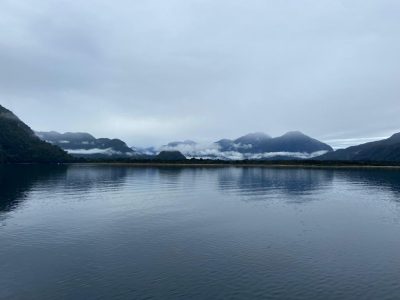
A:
[[216, 131, 333, 154]]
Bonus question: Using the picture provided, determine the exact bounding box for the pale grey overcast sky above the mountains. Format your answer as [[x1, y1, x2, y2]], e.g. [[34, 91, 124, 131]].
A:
[[0, 0, 400, 147]]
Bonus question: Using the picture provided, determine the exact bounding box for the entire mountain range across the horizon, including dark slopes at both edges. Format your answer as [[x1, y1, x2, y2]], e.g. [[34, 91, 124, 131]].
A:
[[0, 106, 400, 163]]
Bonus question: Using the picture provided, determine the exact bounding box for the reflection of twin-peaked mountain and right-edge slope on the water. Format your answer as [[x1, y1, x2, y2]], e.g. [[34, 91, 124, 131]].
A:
[[218, 168, 400, 202]]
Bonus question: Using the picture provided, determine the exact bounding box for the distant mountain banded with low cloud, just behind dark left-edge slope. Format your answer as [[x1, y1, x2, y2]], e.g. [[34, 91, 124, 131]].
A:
[[36, 131, 136, 157]]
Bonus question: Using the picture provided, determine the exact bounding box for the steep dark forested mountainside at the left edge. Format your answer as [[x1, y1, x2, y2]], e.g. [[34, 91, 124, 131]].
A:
[[0, 105, 72, 163]]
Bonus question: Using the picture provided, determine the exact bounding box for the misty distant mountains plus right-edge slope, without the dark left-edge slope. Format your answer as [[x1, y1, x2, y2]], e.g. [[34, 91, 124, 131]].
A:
[[32, 131, 400, 162]]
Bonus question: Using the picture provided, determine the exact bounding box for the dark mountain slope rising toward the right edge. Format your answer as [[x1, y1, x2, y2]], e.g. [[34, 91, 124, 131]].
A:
[[315, 133, 400, 162]]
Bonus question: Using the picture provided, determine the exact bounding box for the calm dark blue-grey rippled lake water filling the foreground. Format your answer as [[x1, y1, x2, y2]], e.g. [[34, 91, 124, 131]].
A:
[[0, 166, 400, 300]]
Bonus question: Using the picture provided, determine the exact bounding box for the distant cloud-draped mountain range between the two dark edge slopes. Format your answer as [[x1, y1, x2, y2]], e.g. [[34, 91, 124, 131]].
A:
[[36, 131, 333, 160]]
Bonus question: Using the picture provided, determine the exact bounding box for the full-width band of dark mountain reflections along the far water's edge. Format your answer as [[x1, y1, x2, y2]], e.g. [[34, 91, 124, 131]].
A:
[[0, 165, 400, 213]]
